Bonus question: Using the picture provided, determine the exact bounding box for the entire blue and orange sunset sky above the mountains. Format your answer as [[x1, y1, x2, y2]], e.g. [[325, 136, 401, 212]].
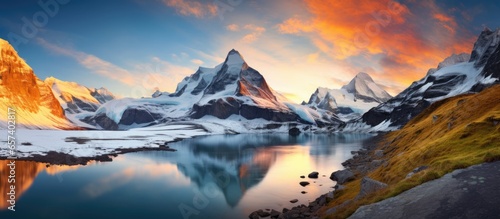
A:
[[0, 0, 500, 102]]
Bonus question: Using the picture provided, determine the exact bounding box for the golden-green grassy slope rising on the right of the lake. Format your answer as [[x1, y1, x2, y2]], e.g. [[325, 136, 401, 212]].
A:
[[327, 85, 500, 218]]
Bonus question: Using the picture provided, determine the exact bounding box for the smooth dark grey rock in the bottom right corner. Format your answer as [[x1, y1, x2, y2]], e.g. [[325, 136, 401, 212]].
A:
[[349, 162, 500, 219]]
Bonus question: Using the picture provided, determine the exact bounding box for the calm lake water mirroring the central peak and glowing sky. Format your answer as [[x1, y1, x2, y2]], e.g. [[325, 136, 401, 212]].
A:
[[0, 134, 371, 218]]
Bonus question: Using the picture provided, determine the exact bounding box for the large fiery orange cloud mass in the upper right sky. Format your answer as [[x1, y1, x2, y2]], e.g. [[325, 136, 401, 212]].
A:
[[276, 0, 475, 93]]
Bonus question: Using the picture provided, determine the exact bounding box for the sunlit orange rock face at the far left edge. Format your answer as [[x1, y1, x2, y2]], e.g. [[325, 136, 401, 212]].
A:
[[0, 39, 70, 128]]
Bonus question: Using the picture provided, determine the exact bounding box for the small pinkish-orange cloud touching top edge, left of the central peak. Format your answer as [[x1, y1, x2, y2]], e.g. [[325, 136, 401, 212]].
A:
[[163, 0, 217, 18]]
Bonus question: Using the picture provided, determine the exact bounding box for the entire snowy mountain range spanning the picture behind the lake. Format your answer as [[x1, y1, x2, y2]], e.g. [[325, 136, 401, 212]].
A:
[[0, 29, 500, 131]]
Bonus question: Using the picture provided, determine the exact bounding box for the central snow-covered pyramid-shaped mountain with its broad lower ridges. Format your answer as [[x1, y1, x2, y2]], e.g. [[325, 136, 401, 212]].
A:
[[89, 49, 341, 129]]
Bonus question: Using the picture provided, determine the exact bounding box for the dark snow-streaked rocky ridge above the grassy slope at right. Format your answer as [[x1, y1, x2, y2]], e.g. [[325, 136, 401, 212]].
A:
[[362, 29, 500, 128]]
